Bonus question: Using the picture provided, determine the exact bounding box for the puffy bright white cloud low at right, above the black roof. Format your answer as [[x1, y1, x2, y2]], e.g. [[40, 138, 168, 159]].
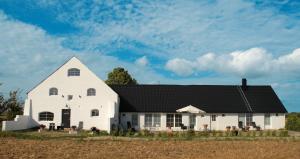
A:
[[166, 48, 300, 78]]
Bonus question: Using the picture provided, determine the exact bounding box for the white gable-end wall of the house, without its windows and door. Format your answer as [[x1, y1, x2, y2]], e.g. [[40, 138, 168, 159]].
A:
[[24, 57, 119, 130]]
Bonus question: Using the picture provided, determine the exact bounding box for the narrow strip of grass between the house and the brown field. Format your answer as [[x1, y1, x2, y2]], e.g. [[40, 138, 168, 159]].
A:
[[0, 130, 297, 140]]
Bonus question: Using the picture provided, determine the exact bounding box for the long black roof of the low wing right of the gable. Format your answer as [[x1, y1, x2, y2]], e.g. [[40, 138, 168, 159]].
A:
[[110, 85, 287, 113]]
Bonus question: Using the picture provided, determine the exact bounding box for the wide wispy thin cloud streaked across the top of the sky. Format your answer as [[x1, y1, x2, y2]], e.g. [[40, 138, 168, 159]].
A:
[[31, 0, 300, 59]]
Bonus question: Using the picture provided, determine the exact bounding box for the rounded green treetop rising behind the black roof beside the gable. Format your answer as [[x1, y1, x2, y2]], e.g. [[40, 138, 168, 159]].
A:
[[105, 67, 138, 85]]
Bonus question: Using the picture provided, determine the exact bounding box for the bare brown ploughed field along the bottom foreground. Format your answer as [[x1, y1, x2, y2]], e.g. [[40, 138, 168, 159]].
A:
[[0, 138, 300, 159]]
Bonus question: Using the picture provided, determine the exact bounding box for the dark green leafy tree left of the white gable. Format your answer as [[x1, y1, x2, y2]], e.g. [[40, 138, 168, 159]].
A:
[[4, 90, 23, 120]]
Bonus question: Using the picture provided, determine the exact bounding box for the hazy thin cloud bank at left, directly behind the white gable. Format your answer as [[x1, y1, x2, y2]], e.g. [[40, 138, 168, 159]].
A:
[[0, 11, 168, 95]]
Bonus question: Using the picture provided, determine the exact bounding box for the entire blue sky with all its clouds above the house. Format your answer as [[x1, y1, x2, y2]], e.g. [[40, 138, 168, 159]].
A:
[[0, 0, 300, 112]]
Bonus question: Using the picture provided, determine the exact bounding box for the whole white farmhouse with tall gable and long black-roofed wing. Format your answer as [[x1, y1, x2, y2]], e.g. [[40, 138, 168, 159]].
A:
[[2, 57, 287, 132]]
